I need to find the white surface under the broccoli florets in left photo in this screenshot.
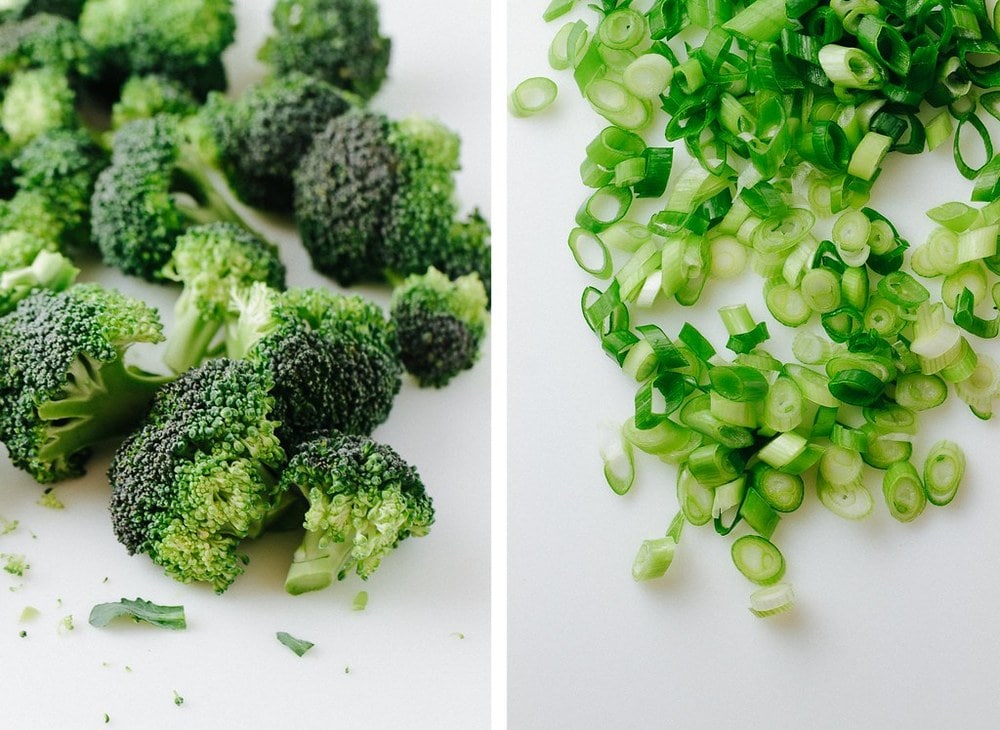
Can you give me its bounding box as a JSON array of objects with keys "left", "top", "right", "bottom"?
[{"left": 0, "top": 0, "right": 490, "bottom": 730}]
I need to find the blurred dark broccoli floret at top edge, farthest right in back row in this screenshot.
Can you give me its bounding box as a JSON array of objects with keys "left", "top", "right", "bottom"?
[{"left": 259, "top": 0, "right": 391, "bottom": 99}]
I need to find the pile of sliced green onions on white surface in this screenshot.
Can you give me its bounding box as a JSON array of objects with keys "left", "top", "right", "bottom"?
[{"left": 511, "top": 0, "right": 1000, "bottom": 616}]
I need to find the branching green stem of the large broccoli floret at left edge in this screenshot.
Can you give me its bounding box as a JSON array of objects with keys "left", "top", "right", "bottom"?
[{"left": 38, "top": 356, "right": 173, "bottom": 461}]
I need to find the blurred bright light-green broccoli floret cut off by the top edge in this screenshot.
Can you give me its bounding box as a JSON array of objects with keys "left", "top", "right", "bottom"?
[{"left": 80, "top": 0, "right": 236, "bottom": 97}]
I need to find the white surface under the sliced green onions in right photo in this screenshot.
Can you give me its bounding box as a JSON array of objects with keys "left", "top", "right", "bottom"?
[{"left": 507, "top": 0, "right": 1000, "bottom": 730}]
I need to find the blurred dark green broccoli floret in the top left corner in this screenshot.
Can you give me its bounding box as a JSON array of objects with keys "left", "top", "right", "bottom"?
[{"left": 0, "top": 13, "right": 94, "bottom": 76}]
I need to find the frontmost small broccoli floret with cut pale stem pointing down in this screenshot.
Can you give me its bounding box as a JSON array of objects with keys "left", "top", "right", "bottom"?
[{"left": 281, "top": 434, "right": 434, "bottom": 594}]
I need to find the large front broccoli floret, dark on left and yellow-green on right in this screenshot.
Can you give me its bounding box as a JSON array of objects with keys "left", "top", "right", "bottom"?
[{"left": 108, "top": 358, "right": 292, "bottom": 592}]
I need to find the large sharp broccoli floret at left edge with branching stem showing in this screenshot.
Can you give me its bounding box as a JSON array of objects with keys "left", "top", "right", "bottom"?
[{"left": 0, "top": 284, "right": 166, "bottom": 483}]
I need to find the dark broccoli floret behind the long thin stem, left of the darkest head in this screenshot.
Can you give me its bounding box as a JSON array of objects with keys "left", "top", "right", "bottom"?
[{"left": 206, "top": 72, "right": 351, "bottom": 211}]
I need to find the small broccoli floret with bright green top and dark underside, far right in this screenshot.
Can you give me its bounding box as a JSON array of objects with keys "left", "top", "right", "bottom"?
[{"left": 389, "top": 267, "right": 489, "bottom": 388}]
